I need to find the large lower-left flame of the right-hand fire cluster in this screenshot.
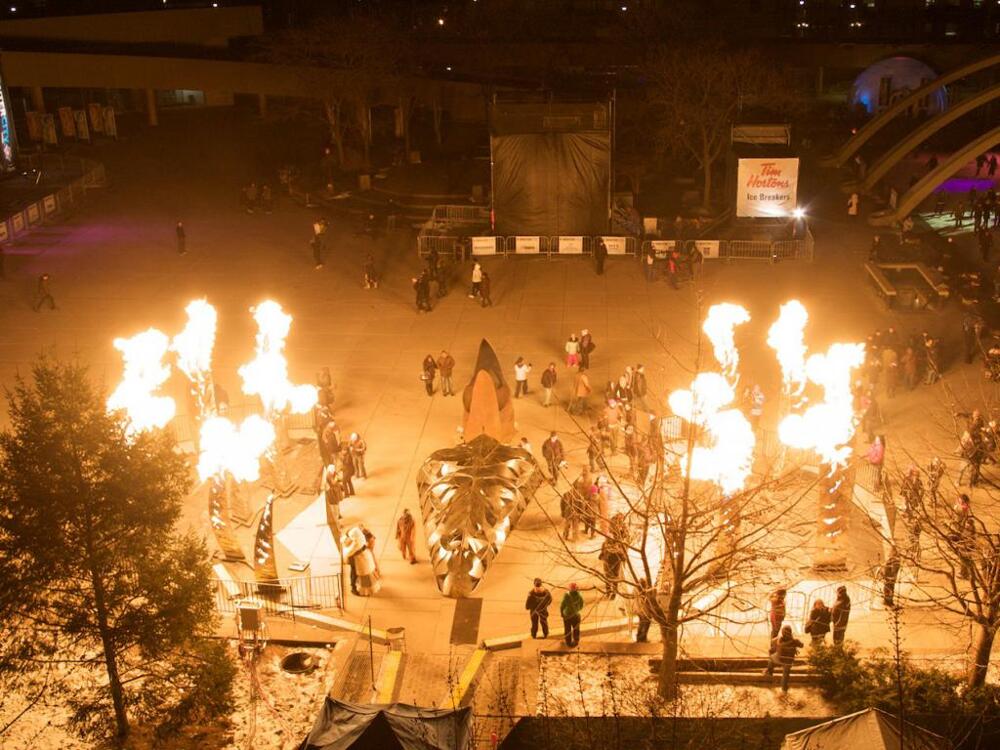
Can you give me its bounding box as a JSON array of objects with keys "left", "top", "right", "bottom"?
[{"left": 668, "top": 372, "right": 757, "bottom": 496}]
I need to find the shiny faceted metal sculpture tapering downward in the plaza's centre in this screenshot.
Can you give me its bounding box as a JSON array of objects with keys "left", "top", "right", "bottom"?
[{"left": 417, "top": 434, "right": 542, "bottom": 598}]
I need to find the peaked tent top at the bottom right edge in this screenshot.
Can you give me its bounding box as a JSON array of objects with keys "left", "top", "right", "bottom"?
[{"left": 781, "top": 708, "right": 951, "bottom": 750}]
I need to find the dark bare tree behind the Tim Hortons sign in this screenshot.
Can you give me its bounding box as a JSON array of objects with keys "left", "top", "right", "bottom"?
[{"left": 644, "top": 43, "right": 794, "bottom": 209}]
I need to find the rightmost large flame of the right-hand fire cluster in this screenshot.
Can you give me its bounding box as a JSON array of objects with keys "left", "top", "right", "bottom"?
[{"left": 778, "top": 344, "right": 865, "bottom": 467}]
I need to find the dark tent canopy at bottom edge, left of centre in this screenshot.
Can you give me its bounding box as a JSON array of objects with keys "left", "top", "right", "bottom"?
[{"left": 299, "top": 697, "right": 472, "bottom": 750}]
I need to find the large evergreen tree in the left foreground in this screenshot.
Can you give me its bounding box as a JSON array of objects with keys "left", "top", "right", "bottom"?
[{"left": 0, "top": 358, "right": 234, "bottom": 742}]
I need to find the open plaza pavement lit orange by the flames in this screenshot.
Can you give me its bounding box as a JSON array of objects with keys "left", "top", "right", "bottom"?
[{"left": 0, "top": 113, "right": 992, "bottom": 703}]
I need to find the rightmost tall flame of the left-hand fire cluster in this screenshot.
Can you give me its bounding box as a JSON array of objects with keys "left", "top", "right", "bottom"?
[{"left": 239, "top": 300, "right": 318, "bottom": 415}]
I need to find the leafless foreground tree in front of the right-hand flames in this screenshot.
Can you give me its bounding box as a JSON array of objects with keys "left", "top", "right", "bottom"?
[{"left": 544, "top": 324, "right": 815, "bottom": 701}]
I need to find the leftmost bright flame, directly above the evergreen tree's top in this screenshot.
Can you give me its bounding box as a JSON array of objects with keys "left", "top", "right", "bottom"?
[{"left": 108, "top": 328, "right": 176, "bottom": 434}]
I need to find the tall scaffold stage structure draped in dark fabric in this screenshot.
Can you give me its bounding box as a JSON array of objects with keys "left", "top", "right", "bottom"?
[{"left": 490, "top": 97, "right": 614, "bottom": 237}]
